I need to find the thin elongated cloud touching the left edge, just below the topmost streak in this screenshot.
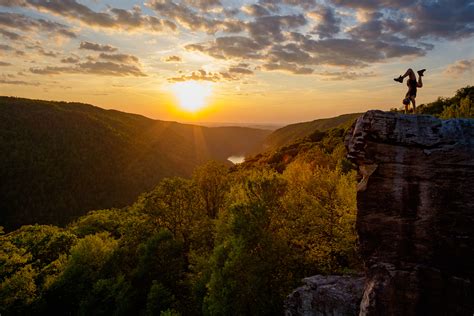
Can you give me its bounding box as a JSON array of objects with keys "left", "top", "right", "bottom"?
[{"left": 0, "top": 11, "right": 77, "bottom": 38}]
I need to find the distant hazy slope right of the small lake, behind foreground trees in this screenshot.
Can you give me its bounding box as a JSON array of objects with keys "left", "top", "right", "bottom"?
[{"left": 263, "top": 113, "right": 361, "bottom": 151}]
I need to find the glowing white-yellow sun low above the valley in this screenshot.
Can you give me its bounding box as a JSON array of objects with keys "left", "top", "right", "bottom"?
[{"left": 171, "top": 81, "right": 212, "bottom": 113}]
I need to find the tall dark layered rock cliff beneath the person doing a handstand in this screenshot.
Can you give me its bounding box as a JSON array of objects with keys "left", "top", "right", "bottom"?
[{"left": 288, "top": 111, "right": 474, "bottom": 316}]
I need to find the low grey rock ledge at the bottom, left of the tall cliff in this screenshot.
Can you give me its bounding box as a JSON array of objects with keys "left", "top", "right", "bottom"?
[{"left": 285, "top": 275, "right": 365, "bottom": 316}]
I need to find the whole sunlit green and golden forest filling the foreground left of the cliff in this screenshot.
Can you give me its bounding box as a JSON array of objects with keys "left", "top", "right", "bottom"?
[{"left": 0, "top": 129, "right": 359, "bottom": 315}]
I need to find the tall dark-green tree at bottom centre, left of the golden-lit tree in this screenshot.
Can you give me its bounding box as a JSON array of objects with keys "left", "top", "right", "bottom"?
[{"left": 205, "top": 171, "right": 292, "bottom": 315}]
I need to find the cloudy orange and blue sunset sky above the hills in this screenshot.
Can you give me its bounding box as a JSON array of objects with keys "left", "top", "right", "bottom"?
[{"left": 0, "top": 0, "right": 474, "bottom": 124}]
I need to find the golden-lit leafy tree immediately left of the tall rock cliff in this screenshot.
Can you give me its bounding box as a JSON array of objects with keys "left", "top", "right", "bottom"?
[{"left": 278, "top": 161, "right": 357, "bottom": 275}]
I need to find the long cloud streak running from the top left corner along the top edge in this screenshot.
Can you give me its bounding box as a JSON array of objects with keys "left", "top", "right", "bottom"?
[{"left": 0, "top": 0, "right": 176, "bottom": 32}]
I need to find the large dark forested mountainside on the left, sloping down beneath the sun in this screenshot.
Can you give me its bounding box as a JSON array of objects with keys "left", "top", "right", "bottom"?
[{"left": 0, "top": 97, "right": 269, "bottom": 229}]
